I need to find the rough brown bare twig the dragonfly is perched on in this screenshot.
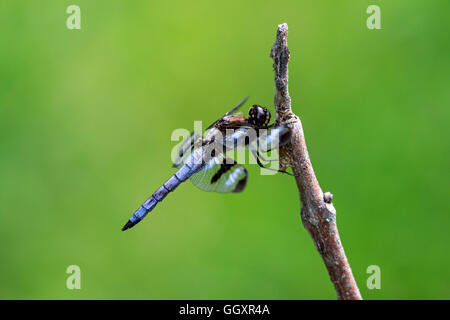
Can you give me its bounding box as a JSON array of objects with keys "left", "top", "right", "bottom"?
[{"left": 270, "top": 23, "right": 362, "bottom": 300}]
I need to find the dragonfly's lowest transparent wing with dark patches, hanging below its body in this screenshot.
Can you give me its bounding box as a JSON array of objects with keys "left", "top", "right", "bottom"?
[{"left": 190, "top": 156, "right": 248, "bottom": 193}]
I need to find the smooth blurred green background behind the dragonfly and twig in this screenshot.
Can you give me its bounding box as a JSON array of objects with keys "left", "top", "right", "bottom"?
[{"left": 0, "top": 0, "right": 450, "bottom": 299}]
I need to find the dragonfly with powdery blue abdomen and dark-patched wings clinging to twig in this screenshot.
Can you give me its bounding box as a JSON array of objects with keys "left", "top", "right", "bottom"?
[{"left": 122, "top": 97, "right": 293, "bottom": 231}]
